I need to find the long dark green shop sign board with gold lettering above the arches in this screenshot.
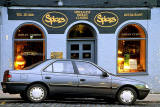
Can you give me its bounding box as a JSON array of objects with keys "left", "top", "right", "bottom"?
[{"left": 8, "top": 8, "right": 151, "bottom": 34}]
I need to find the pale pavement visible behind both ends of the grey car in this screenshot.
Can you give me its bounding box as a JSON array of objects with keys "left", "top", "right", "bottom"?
[{"left": 0, "top": 90, "right": 160, "bottom": 103}]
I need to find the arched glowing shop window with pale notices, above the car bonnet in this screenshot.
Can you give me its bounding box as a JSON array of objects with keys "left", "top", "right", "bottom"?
[{"left": 117, "top": 24, "right": 146, "bottom": 73}]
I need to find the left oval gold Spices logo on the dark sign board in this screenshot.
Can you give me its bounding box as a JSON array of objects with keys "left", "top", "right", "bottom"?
[{"left": 42, "top": 11, "right": 68, "bottom": 28}]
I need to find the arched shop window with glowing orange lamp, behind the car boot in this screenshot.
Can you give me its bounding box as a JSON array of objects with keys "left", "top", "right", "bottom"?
[{"left": 14, "top": 24, "right": 45, "bottom": 70}]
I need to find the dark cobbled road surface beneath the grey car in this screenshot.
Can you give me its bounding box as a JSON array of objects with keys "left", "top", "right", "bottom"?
[{"left": 0, "top": 98, "right": 160, "bottom": 107}]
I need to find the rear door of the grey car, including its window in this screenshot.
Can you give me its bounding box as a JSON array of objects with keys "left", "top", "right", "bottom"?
[{"left": 43, "top": 60, "right": 78, "bottom": 94}]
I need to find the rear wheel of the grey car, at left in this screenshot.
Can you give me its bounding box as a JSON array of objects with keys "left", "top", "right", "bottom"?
[{"left": 27, "top": 84, "right": 47, "bottom": 103}]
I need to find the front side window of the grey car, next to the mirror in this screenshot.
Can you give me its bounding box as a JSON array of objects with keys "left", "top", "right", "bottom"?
[{"left": 75, "top": 62, "right": 102, "bottom": 76}]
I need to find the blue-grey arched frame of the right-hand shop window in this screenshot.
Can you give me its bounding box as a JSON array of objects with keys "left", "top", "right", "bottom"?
[{"left": 116, "top": 23, "right": 148, "bottom": 76}]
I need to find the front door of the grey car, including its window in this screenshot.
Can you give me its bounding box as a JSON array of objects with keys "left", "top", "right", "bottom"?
[{"left": 75, "top": 61, "right": 111, "bottom": 96}]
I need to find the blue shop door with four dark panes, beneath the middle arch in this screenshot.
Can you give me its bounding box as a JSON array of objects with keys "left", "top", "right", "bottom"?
[{"left": 67, "top": 40, "right": 95, "bottom": 62}]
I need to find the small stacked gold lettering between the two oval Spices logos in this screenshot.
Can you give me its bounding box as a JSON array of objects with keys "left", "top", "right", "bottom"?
[{"left": 74, "top": 10, "right": 91, "bottom": 19}]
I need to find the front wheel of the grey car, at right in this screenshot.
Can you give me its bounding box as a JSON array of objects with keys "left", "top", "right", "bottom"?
[{"left": 117, "top": 87, "right": 137, "bottom": 105}]
